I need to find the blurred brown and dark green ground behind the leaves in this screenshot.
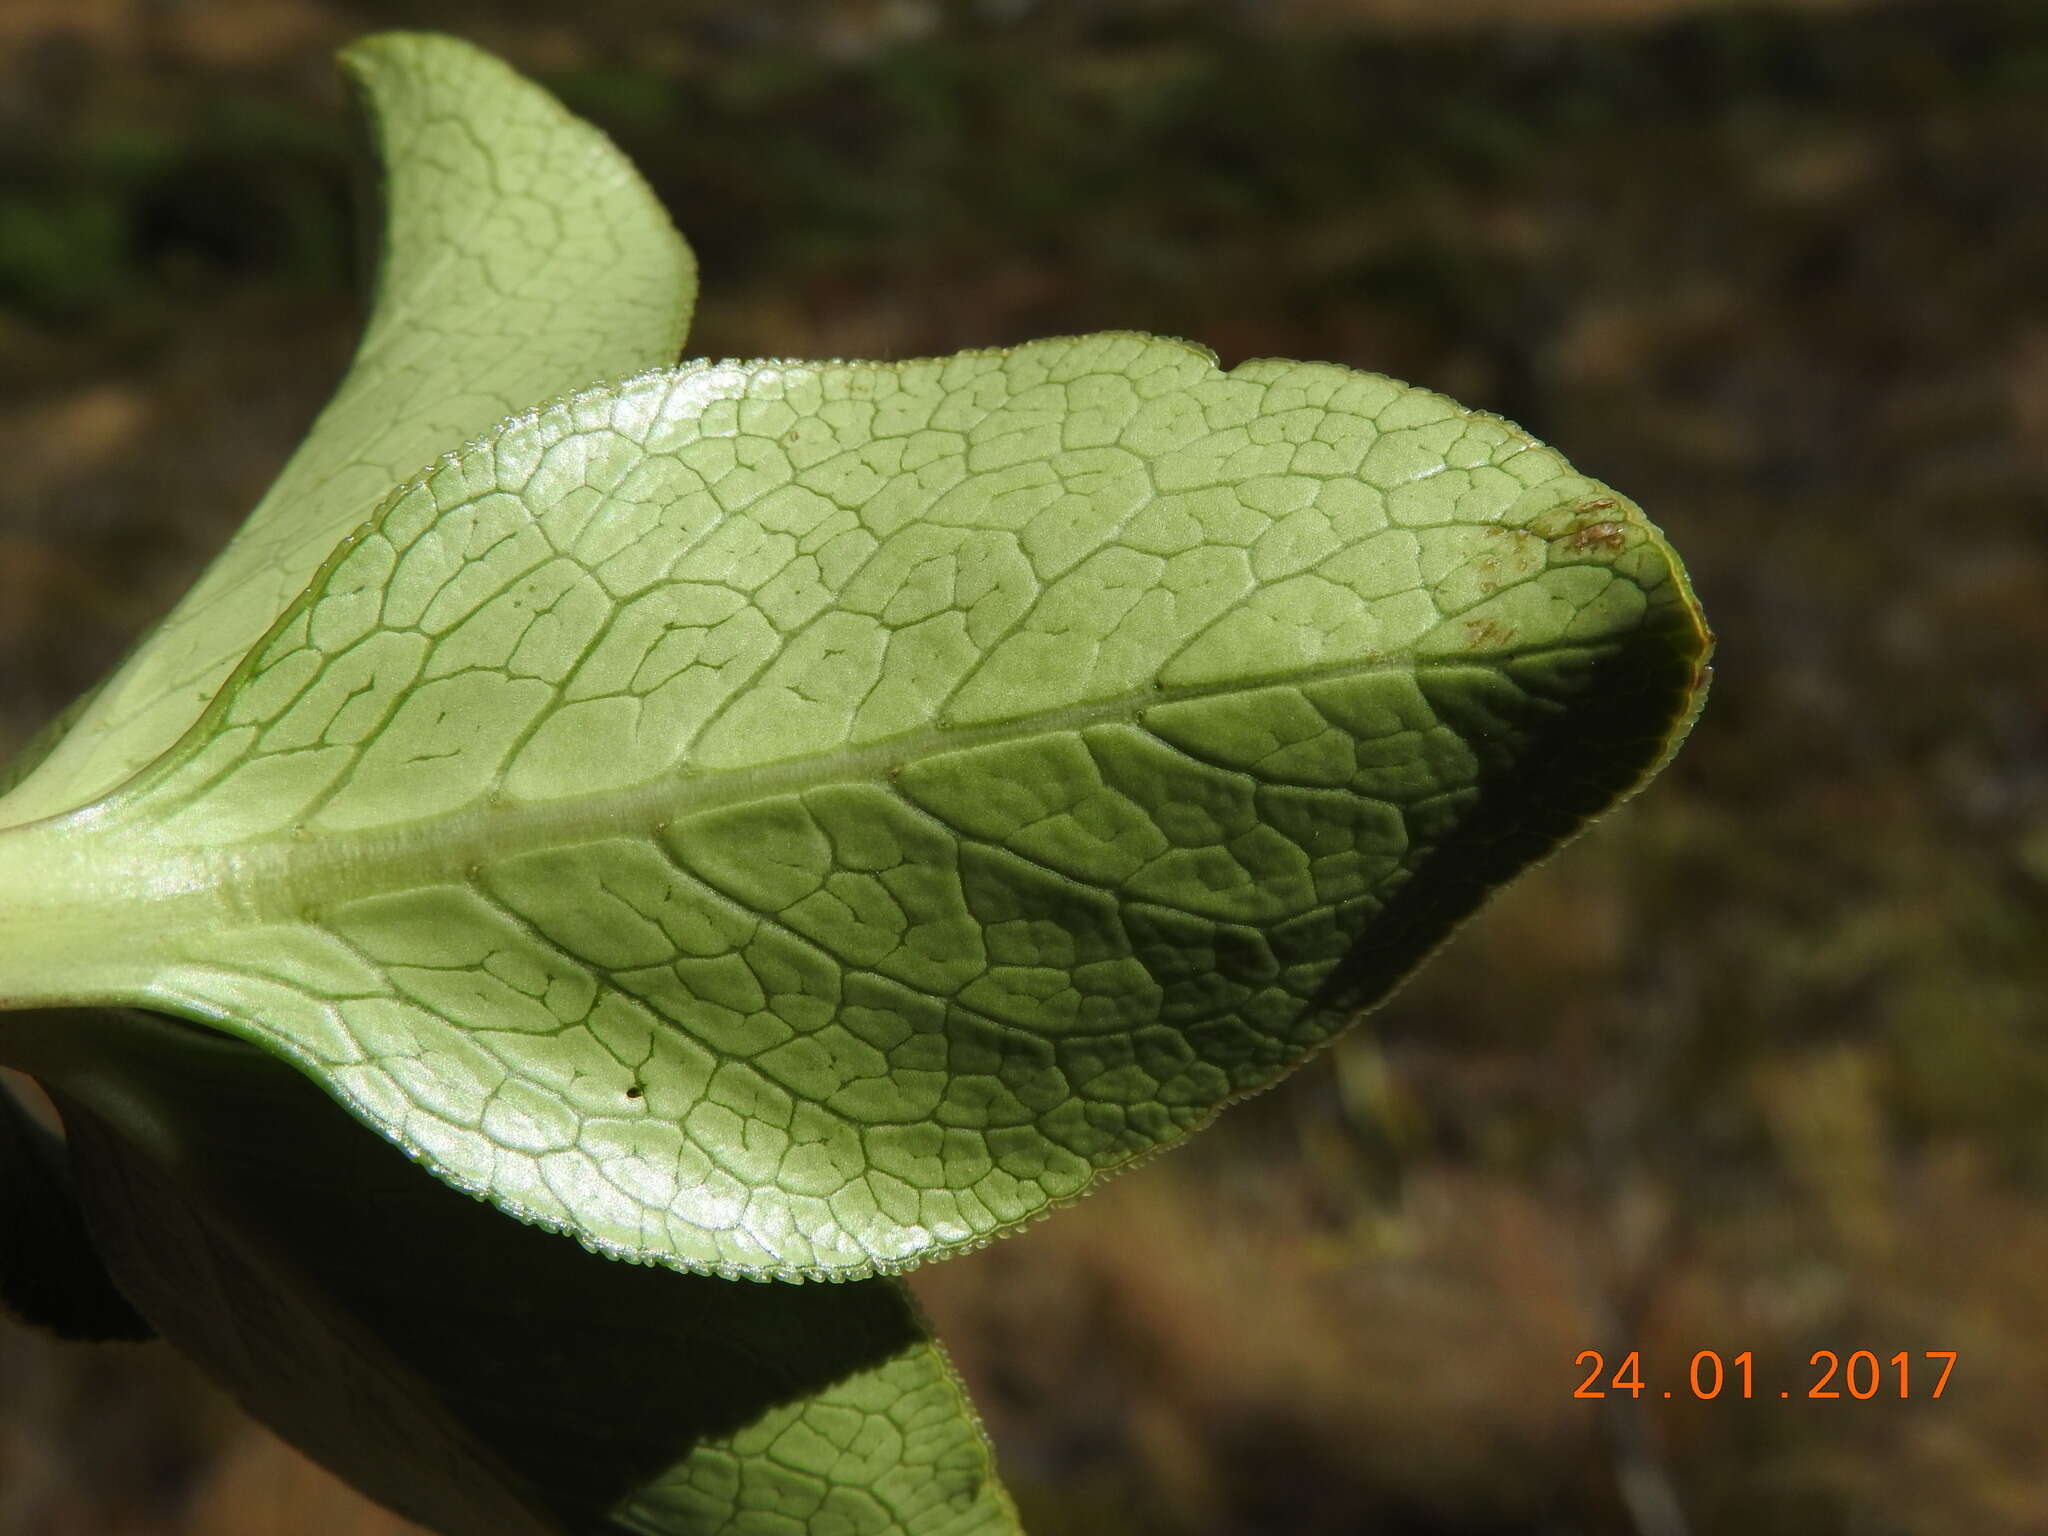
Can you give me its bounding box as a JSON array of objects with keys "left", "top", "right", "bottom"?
[{"left": 0, "top": 0, "right": 2048, "bottom": 1536}]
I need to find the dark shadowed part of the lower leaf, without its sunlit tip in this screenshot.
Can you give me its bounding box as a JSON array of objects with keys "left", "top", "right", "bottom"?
[{"left": 18, "top": 1012, "right": 922, "bottom": 1532}]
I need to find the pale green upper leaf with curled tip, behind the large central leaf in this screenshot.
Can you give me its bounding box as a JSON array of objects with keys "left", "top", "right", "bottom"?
[{"left": 0, "top": 33, "right": 696, "bottom": 821}]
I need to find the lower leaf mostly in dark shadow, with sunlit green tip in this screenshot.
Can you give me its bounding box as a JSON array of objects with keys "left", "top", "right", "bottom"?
[{"left": 23, "top": 1012, "right": 1016, "bottom": 1536}]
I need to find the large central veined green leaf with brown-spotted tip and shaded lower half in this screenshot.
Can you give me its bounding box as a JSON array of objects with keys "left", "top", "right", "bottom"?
[{"left": 0, "top": 334, "right": 1706, "bottom": 1276}]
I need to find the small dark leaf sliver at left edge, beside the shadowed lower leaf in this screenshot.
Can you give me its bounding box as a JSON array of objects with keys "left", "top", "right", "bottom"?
[{"left": 0, "top": 1081, "right": 152, "bottom": 1339}]
